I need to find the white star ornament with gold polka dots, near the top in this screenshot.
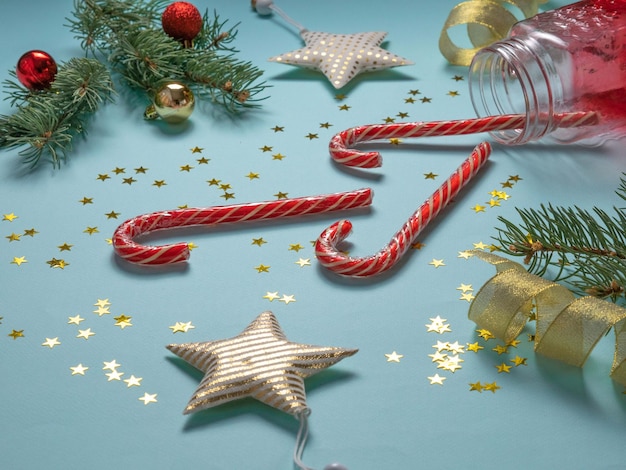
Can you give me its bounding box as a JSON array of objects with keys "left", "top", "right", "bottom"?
[{"left": 269, "top": 30, "right": 413, "bottom": 89}]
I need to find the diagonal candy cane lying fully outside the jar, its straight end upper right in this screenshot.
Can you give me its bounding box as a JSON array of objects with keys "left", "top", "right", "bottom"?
[{"left": 315, "top": 142, "right": 491, "bottom": 277}]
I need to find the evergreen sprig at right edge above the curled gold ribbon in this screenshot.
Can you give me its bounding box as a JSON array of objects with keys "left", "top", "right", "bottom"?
[{"left": 495, "top": 174, "right": 626, "bottom": 303}]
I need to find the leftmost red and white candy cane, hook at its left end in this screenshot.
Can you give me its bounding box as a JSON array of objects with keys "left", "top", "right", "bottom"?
[{"left": 112, "top": 188, "right": 372, "bottom": 265}]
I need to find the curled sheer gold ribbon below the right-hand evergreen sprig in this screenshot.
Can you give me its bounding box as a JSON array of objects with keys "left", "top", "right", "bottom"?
[{"left": 468, "top": 251, "right": 626, "bottom": 386}]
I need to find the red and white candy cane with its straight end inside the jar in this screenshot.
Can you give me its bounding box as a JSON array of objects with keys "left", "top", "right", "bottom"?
[{"left": 328, "top": 112, "right": 597, "bottom": 168}]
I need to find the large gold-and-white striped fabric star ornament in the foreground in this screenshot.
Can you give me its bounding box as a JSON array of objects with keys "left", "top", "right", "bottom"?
[{"left": 167, "top": 311, "right": 357, "bottom": 417}]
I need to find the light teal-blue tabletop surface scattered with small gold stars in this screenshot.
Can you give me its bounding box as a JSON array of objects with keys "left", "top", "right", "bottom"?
[{"left": 0, "top": 0, "right": 626, "bottom": 470}]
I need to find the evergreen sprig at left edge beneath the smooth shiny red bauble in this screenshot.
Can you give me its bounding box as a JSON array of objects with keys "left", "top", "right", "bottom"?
[{"left": 0, "top": 58, "right": 114, "bottom": 168}]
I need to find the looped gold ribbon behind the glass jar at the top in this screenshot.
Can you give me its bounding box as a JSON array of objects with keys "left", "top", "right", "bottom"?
[{"left": 439, "top": 0, "right": 547, "bottom": 65}]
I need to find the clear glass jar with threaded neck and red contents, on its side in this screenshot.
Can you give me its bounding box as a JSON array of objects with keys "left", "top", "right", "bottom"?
[{"left": 469, "top": 0, "right": 626, "bottom": 145}]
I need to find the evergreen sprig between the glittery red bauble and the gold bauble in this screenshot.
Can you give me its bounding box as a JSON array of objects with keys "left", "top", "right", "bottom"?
[{"left": 67, "top": 0, "right": 267, "bottom": 112}]
